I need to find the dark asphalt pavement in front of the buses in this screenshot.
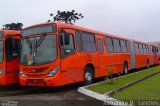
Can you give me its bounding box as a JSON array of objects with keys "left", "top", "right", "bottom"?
[{"left": 0, "top": 83, "right": 104, "bottom": 106}]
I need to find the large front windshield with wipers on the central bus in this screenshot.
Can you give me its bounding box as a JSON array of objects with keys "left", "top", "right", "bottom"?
[{"left": 20, "top": 34, "right": 57, "bottom": 65}]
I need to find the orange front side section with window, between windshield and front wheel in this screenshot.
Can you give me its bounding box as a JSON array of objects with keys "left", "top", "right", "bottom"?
[{"left": 59, "top": 30, "right": 83, "bottom": 83}]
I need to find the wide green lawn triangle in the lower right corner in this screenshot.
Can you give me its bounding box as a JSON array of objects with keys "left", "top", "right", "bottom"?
[{"left": 112, "top": 74, "right": 160, "bottom": 100}]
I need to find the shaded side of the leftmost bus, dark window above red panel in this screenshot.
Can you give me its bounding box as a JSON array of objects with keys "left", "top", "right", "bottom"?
[{"left": 5, "top": 38, "right": 19, "bottom": 83}]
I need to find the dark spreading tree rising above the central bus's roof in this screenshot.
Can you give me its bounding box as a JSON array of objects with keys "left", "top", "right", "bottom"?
[{"left": 48, "top": 10, "right": 84, "bottom": 24}]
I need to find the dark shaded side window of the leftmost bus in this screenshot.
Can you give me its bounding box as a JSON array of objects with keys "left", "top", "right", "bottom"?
[{"left": 6, "top": 38, "right": 19, "bottom": 61}]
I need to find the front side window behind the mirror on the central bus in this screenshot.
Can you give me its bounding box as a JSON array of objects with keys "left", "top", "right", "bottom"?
[{"left": 60, "top": 33, "right": 75, "bottom": 58}]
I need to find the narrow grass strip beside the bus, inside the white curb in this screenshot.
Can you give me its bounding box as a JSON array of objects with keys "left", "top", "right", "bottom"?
[{"left": 87, "top": 66, "right": 160, "bottom": 94}]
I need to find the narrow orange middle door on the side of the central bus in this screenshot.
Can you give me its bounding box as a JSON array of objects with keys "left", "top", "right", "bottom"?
[{"left": 96, "top": 35, "right": 106, "bottom": 76}]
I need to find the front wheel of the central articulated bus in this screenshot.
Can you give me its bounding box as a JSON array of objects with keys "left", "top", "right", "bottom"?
[{"left": 84, "top": 67, "right": 94, "bottom": 85}]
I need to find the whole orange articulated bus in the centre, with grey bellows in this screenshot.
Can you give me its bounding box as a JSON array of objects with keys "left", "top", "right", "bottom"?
[{"left": 19, "top": 22, "right": 153, "bottom": 86}]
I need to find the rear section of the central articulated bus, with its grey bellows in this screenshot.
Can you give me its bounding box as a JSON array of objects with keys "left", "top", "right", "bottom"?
[{"left": 130, "top": 40, "right": 154, "bottom": 69}]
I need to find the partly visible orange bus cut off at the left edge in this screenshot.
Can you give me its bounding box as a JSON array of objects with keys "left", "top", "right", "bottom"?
[{"left": 0, "top": 30, "right": 21, "bottom": 85}]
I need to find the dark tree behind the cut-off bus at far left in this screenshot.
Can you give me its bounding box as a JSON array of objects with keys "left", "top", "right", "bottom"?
[{"left": 2, "top": 23, "right": 23, "bottom": 30}]
